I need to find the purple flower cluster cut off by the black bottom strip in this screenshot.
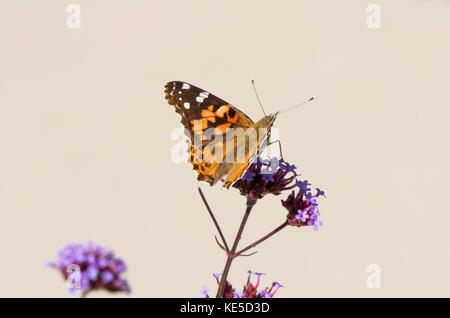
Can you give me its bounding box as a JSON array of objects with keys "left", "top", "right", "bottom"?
[{"left": 201, "top": 271, "right": 283, "bottom": 298}]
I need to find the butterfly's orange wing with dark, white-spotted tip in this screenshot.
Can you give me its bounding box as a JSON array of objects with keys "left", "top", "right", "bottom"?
[{"left": 165, "top": 81, "right": 254, "bottom": 188}]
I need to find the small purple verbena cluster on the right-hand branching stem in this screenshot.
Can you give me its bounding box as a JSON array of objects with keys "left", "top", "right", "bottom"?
[{"left": 281, "top": 180, "right": 325, "bottom": 231}]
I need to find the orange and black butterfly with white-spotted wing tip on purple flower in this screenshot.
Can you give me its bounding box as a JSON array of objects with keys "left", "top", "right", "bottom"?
[{"left": 165, "top": 81, "right": 278, "bottom": 189}]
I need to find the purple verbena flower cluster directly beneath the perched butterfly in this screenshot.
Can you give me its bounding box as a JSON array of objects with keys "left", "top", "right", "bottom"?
[{"left": 233, "top": 157, "right": 297, "bottom": 199}]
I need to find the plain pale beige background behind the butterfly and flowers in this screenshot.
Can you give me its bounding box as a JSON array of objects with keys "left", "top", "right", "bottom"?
[{"left": 0, "top": 0, "right": 450, "bottom": 297}]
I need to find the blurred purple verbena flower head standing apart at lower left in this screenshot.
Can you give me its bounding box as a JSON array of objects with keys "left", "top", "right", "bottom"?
[{"left": 48, "top": 242, "right": 130, "bottom": 294}]
